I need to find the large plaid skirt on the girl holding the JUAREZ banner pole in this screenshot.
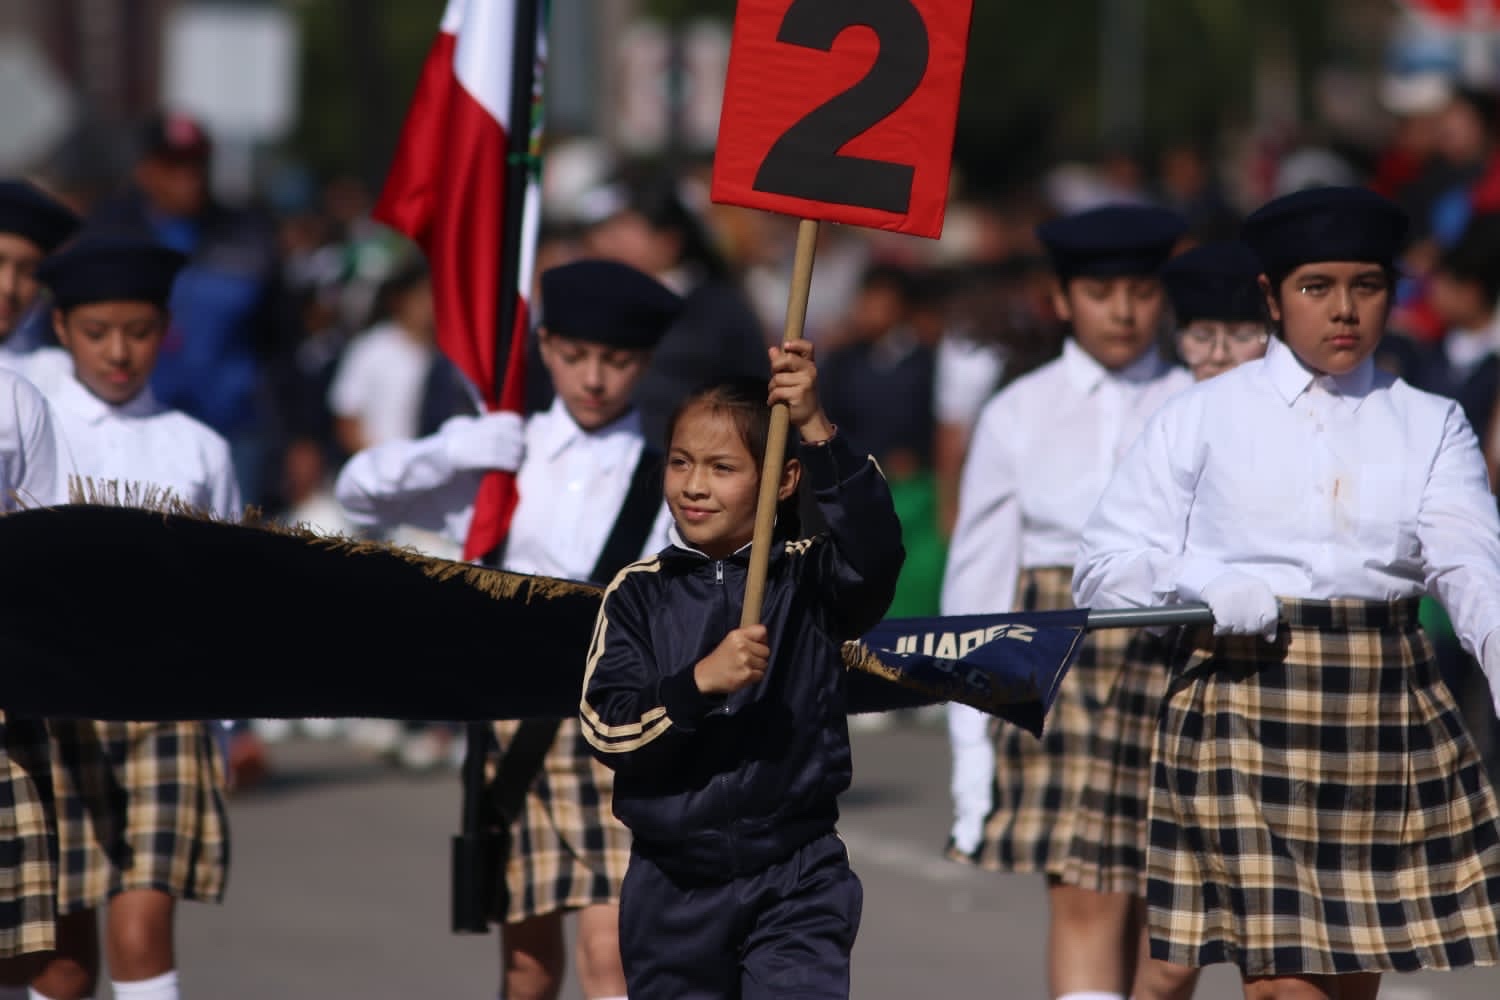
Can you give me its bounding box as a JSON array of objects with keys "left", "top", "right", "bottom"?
[{"left": 1148, "top": 598, "right": 1500, "bottom": 976}]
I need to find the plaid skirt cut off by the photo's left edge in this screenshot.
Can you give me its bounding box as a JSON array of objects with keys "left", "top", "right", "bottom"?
[{"left": 0, "top": 715, "right": 57, "bottom": 958}]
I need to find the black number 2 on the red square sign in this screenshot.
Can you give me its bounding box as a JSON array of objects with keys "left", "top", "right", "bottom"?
[{"left": 755, "top": 0, "right": 930, "bottom": 214}]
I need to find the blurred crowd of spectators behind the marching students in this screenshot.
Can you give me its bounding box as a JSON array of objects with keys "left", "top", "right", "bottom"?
[{"left": 0, "top": 0, "right": 1500, "bottom": 766}]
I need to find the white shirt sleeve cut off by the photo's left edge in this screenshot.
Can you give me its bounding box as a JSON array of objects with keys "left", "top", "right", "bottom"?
[{"left": 0, "top": 369, "right": 72, "bottom": 511}]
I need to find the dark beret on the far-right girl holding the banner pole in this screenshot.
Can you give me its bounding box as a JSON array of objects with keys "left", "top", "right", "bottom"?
[{"left": 1241, "top": 187, "right": 1410, "bottom": 280}]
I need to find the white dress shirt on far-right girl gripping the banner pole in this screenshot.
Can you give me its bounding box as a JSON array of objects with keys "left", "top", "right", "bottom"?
[{"left": 1074, "top": 339, "right": 1500, "bottom": 671}]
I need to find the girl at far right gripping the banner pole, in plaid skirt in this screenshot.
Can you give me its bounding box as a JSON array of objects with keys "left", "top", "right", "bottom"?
[{"left": 1074, "top": 187, "right": 1500, "bottom": 1000}]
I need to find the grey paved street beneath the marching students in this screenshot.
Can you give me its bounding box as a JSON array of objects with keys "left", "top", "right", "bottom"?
[{"left": 138, "top": 727, "right": 1500, "bottom": 1000}]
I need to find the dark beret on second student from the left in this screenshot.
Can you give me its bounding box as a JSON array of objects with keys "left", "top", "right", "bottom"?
[{"left": 36, "top": 235, "right": 188, "bottom": 309}]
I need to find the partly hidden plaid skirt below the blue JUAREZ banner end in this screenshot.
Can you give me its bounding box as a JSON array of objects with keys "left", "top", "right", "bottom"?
[{"left": 969, "top": 567, "right": 1131, "bottom": 876}]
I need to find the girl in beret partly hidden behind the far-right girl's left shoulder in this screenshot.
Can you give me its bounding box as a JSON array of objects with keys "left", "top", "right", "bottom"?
[{"left": 942, "top": 205, "right": 1193, "bottom": 1000}]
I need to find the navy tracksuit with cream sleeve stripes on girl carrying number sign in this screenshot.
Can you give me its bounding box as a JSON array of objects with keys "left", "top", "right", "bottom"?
[{"left": 581, "top": 435, "right": 905, "bottom": 1000}]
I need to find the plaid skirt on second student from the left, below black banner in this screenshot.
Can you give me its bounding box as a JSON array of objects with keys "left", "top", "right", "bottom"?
[{"left": 48, "top": 720, "right": 230, "bottom": 913}]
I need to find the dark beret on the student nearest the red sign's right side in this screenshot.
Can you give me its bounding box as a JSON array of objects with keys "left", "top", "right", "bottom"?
[{"left": 1037, "top": 204, "right": 1188, "bottom": 280}]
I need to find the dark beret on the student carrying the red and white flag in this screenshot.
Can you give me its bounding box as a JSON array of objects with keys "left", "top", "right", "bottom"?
[{"left": 542, "top": 259, "right": 683, "bottom": 351}]
